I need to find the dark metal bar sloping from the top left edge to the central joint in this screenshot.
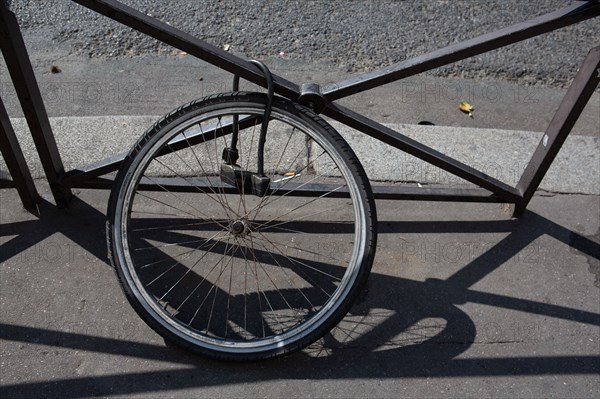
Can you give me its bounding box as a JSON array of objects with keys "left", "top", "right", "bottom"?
[{"left": 73, "top": 0, "right": 299, "bottom": 100}]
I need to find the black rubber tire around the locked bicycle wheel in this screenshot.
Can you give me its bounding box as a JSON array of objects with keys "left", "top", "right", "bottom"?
[{"left": 106, "top": 92, "right": 376, "bottom": 361}]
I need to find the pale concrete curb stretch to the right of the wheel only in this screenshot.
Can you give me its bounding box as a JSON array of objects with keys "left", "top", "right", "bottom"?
[{"left": 333, "top": 123, "right": 600, "bottom": 195}]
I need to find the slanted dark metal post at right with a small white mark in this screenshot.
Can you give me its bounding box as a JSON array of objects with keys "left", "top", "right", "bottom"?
[{"left": 514, "top": 46, "right": 600, "bottom": 217}]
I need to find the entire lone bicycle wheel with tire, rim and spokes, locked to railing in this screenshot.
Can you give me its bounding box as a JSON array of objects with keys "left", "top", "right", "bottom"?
[{"left": 107, "top": 93, "right": 376, "bottom": 361}]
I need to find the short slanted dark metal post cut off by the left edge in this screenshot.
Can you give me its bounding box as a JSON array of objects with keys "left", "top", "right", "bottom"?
[{"left": 0, "top": 98, "right": 39, "bottom": 214}]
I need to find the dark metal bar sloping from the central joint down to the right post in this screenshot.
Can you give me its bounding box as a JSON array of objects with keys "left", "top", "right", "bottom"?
[{"left": 323, "top": 103, "right": 520, "bottom": 202}]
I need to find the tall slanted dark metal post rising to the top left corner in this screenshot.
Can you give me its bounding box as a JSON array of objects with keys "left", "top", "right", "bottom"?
[{"left": 0, "top": 2, "right": 71, "bottom": 207}]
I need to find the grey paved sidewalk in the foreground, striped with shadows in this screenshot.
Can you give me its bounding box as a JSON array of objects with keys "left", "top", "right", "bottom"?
[{"left": 0, "top": 182, "right": 600, "bottom": 398}]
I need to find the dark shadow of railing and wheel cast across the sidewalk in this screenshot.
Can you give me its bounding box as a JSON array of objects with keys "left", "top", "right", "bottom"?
[{"left": 0, "top": 196, "right": 600, "bottom": 398}]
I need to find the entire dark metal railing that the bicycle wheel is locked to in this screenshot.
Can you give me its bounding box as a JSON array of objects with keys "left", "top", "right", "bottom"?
[{"left": 0, "top": 0, "right": 600, "bottom": 216}]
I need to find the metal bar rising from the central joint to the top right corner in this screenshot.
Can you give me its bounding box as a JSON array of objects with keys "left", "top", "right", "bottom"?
[{"left": 321, "top": 1, "right": 600, "bottom": 101}]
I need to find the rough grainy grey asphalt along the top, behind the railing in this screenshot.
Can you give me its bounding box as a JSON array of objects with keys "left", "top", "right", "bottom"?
[{"left": 7, "top": 0, "right": 600, "bottom": 86}]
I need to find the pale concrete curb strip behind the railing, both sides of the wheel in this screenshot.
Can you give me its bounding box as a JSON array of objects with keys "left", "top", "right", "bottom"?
[{"left": 0, "top": 116, "right": 600, "bottom": 195}]
